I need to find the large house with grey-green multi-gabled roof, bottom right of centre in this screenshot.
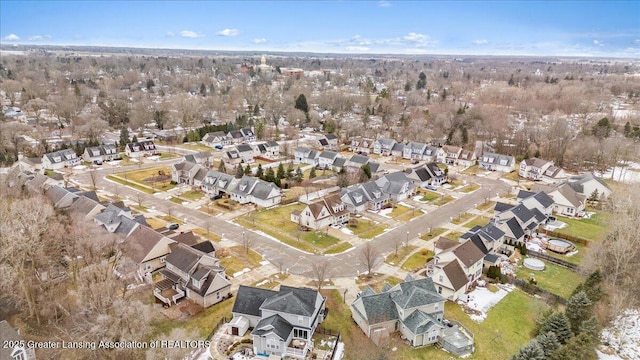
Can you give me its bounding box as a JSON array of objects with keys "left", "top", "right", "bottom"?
[{"left": 350, "top": 277, "right": 460, "bottom": 347}]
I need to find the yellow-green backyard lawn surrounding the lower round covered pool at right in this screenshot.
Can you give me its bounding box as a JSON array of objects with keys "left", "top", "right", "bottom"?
[{"left": 516, "top": 262, "right": 584, "bottom": 298}]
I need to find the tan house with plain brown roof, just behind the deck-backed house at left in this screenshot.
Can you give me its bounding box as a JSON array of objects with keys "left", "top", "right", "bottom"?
[{"left": 120, "top": 225, "right": 176, "bottom": 278}]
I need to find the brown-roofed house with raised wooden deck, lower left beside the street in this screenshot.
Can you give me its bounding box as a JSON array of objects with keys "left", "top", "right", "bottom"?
[{"left": 153, "top": 241, "right": 231, "bottom": 308}]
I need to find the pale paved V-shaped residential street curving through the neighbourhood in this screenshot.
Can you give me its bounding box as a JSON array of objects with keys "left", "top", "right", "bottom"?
[{"left": 73, "top": 163, "right": 510, "bottom": 277}]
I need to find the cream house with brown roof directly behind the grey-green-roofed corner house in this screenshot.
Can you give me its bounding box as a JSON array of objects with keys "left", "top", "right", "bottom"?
[{"left": 431, "top": 240, "right": 485, "bottom": 301}]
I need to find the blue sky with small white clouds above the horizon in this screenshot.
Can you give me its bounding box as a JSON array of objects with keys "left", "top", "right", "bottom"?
[{"left": 0, "top": 0, "right": 640, "bottom": 58}]
